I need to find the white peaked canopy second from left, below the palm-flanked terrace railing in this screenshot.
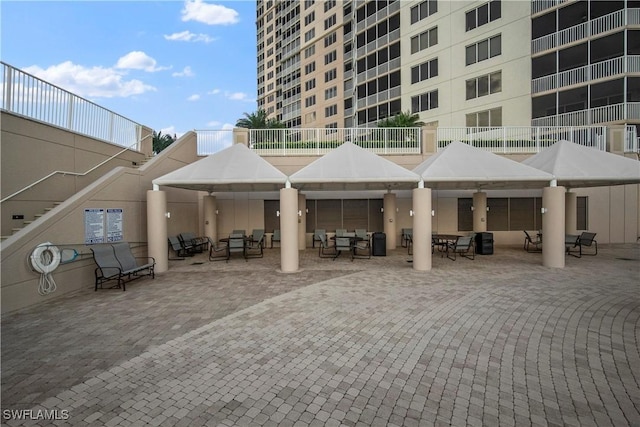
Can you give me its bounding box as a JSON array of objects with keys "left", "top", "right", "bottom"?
[{"left": 289, "top": 142, "right": 420, "bottom": 191}]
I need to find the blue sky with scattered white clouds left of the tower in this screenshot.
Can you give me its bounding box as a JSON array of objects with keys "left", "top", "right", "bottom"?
[{"left": 0, "top": 0, "right": 257, "bottom": 136}]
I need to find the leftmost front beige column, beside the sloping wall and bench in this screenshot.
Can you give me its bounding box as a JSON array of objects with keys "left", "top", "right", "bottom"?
[{"left": 147, "top": 190, "right": 169, "bottom": 273}]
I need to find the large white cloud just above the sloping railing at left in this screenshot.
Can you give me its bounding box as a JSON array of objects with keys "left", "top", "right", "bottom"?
[{"left": 24, "top": 61, "right": 156, "bottom": 98}]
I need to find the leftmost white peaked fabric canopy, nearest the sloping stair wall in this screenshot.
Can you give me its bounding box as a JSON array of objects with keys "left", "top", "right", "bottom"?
[{"left": 153, "top": 144, "right": 287, "bottom": 192}]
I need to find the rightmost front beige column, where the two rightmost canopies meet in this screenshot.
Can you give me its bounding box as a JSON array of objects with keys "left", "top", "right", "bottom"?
[{"left": 542, "top": 187, "right": 565, "bottom": 268}]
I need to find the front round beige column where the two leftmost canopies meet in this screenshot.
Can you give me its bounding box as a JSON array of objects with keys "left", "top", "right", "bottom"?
[{"left": 280, "top": 188, "right": 299, "bottom": 273}]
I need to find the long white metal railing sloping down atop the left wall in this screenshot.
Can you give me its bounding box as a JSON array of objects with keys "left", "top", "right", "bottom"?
[{"left": 0, "top": 62, "right": 142, "bottom": 151}]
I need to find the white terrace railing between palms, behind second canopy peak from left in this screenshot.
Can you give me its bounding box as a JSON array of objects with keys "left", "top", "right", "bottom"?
[{"left": 249, "top": 128, "right": 422, "bottom": 156}]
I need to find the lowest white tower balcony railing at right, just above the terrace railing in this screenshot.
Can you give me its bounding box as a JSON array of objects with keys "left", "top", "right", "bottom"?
[{"left": 531, "top": 102, "right": 640, "bottom": 126}]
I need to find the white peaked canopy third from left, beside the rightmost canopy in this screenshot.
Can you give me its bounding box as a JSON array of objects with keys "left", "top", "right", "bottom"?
[{"left": 413, "top": 141, "right": 553, "bottom": 190}]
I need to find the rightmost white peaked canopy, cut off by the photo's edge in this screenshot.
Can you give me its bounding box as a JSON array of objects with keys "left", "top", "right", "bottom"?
[{"left": 522, "top": 140, "right": 640, "bottom": 188}]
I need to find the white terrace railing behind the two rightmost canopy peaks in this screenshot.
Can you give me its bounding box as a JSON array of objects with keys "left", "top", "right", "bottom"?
[{"left": 436, "top": 126, "right": 607, "bottom": 154}]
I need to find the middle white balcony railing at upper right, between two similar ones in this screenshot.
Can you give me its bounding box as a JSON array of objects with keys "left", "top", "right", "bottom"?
[{"left": 531, "top": 55, "right": 640, "bottom": 93}]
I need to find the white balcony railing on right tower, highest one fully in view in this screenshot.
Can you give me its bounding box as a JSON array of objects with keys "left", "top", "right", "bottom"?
[{"left": 531, "top": 9, "right": 640, "bottom": 54}]
